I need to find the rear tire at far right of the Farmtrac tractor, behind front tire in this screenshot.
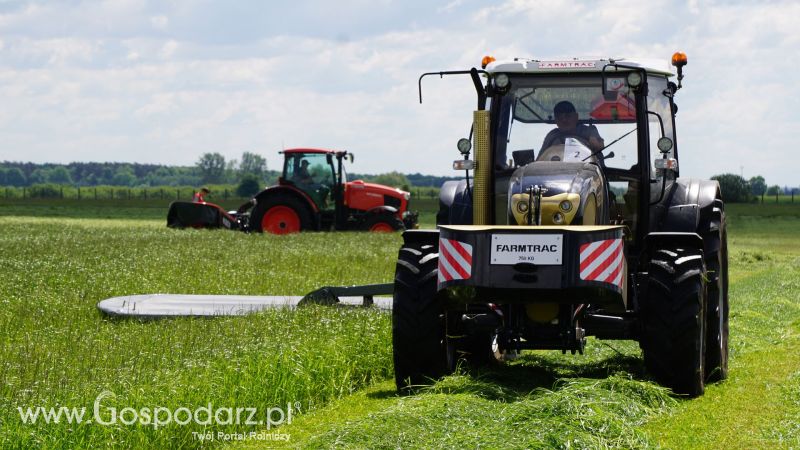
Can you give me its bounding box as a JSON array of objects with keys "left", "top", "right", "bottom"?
[{"left": 702, "top": 199, "right": 729, "bottom": 382}]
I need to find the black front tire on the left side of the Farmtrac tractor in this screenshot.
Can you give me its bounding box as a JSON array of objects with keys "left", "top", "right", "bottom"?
[{"left": 392, "top": 242, "right": 448, "bottom": 393}]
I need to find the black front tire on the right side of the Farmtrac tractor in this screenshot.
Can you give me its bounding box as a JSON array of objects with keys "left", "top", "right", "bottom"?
[{"left": 640, "top": 249, "right": 707, "bottom": 397}]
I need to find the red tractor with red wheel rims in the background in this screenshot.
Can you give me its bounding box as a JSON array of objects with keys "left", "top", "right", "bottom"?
[{"left": 238, "top": 148, "right": 417, "bottom": 234}]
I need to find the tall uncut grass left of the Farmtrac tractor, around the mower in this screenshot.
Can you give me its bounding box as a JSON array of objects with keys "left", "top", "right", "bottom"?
[{"left": 0, "top": 217, "right": 399, "bottom": 448}]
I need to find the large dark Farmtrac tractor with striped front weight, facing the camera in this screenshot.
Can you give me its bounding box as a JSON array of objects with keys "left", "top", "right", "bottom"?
[{"left": 392, "top": 52, "right": 729, "bottom": 397}]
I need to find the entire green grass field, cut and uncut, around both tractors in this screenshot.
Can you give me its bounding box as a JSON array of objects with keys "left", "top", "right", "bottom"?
[{"left": 0, "top": 201, "right": 800, "bottom": 448}]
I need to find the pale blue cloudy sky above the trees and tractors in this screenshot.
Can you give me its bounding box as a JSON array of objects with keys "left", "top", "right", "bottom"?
[{"left": 0, "top": 0, "right": 800, "bottom": 186}]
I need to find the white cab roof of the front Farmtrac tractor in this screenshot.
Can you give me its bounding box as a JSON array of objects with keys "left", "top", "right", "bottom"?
[{"left": 484, "top": 58, "right": 674, "bottom": 77}]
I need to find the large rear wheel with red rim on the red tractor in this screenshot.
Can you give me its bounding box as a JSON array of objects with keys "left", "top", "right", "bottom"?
[{"left": 250, "top": 195, "right": 312, "bottom": 234}]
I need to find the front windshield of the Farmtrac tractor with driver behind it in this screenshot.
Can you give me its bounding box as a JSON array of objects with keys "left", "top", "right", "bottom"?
[{"left": 495, "top": 74, "right": 637, "bottom": 169}]
